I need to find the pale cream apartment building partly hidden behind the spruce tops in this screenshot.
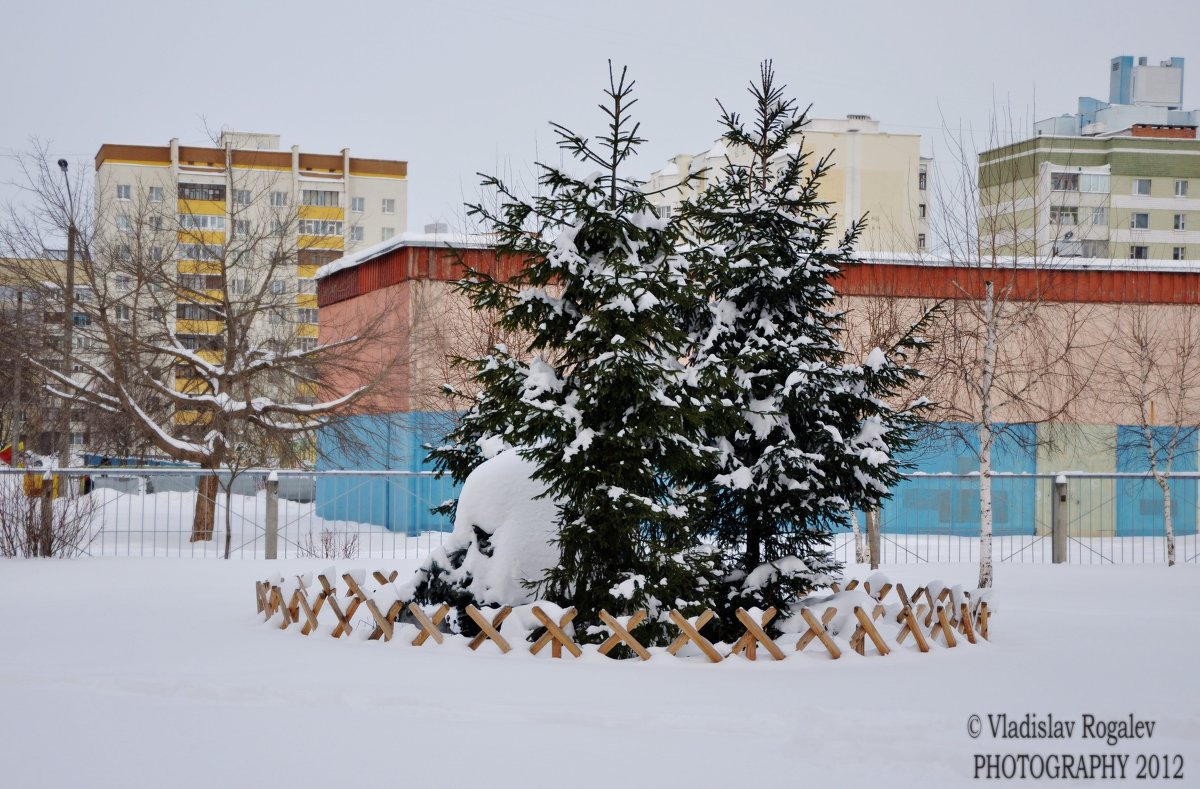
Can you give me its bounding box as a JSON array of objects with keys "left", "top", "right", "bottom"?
[{"left": 643, "top": 115, "right": 932, "bottom": 253}]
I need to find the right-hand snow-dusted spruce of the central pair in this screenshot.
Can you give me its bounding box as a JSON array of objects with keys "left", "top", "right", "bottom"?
[{"left": 684, "top": 61, "right": 922, "bottom": 637}]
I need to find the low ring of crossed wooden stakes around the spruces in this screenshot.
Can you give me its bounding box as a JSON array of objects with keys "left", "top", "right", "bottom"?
[{"left": 254, "top": 567, "right": 994, "bottom": 663}]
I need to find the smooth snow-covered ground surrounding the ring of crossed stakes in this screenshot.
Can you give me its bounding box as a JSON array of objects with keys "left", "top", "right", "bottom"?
[{"left": 0, "top": 559, "right": 1200, "bottom": 789}]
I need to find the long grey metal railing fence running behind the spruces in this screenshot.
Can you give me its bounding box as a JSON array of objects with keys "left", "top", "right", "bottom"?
[{"left": 0, "top": 468, "right": 1200, "bottom": 564}]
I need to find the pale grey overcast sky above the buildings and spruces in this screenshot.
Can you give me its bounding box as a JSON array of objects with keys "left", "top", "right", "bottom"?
[{"left": 0, "top": 0, "right": 1200, "bottom": 230}]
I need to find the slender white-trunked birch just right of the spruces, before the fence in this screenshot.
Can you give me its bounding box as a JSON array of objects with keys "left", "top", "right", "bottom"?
[{"left": 932, "top": 115, "right": 1094, "bottom": 588}]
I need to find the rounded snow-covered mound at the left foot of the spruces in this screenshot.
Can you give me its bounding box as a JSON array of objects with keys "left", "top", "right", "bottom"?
[{"left": 401, "top": 450, "right": 558, "bottom": 606}]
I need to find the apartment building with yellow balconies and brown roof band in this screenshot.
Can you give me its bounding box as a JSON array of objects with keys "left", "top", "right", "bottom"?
[{"left": 91, "top": 132, "right": 408, "bottom": 424}]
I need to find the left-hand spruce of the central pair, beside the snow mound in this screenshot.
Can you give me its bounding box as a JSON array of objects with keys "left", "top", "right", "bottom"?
[{"left": 431, "top": 62, "right": 713, "bottom": 643}]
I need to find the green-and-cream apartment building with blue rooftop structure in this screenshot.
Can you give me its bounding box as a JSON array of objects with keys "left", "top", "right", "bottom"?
[{"left": 979, "top": 55, "right": 1200, "bottom": 260}]
